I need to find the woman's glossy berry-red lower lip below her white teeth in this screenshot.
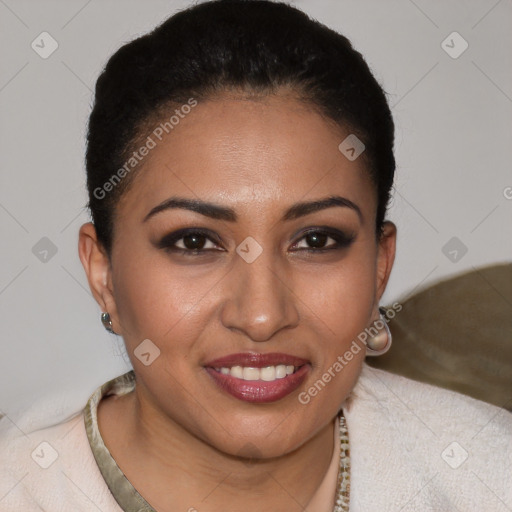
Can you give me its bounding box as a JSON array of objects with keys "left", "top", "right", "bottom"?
[{"left": 206, "top": 364, "right": 309, "bottom": 403}]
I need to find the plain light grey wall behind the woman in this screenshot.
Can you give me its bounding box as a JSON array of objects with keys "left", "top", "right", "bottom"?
[{"left": 0, "top": 0, "right": 512, "bottom": 420}]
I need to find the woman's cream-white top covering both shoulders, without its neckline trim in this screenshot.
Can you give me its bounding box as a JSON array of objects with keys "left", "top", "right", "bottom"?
[{"left": 0, "top": 364, "right": 512, "bottom": 512}]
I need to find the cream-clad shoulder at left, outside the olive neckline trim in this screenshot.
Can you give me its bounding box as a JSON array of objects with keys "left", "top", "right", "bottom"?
[{"left": 0, "top": 400, "right": 121, "bottom": 512}]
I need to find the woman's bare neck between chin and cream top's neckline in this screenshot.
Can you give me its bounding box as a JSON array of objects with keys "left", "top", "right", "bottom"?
[{"left": 112, "top": 387, "right": 334, "bottom": 512}]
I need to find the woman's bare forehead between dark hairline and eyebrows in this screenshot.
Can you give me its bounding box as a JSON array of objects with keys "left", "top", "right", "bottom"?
[{"left": 118, "top": 95, "right": 376, "bottom": 224}]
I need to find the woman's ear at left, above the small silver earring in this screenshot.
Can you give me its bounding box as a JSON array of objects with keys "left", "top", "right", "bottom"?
[{"left": 78, "top": 222, "right": 122, "bottom": 334}]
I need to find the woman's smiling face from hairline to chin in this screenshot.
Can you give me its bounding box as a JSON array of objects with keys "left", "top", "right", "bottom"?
[{"left": 83, "top": 94, "right": 395, "bottom": 457}]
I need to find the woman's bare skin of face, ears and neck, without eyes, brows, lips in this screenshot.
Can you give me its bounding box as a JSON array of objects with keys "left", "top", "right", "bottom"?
[{"left": 79, "top": 92, "right": 396, "bottom": 512}]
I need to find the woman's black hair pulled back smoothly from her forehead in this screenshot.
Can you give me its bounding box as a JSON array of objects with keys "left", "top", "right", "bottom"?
[{"left": 86, "top": 0, "right": 395, "bottom": 255}]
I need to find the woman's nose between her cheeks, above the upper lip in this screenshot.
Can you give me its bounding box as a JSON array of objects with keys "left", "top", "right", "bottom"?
[{"left": 221, "top": 251, "right": 299, "bottom": 342}]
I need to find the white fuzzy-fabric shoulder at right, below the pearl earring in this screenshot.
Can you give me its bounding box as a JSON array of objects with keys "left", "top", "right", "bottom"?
[{"left": 344, "top": 365, "right": 512, "bottom": 511}]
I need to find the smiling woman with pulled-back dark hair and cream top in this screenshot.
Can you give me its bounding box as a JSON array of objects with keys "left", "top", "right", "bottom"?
[{"left": 0, "top": 0, "right": 512, "bottom": 512}]
